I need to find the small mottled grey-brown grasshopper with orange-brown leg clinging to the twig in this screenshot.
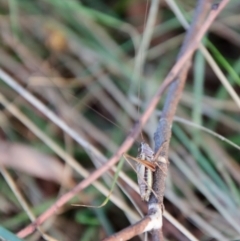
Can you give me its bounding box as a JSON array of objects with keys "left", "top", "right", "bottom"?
[{"left": 125, "top": 142, "right": 156, "bottom": 202}]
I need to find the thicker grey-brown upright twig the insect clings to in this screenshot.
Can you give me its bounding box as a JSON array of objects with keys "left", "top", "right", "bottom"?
[{"left": 149, "top": 0, "right": 230, "bottom": 241}]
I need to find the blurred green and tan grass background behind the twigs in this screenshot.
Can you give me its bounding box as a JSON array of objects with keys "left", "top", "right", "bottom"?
[{"left": 0, "top": 0, "right": 240, "bottom": 241}]
